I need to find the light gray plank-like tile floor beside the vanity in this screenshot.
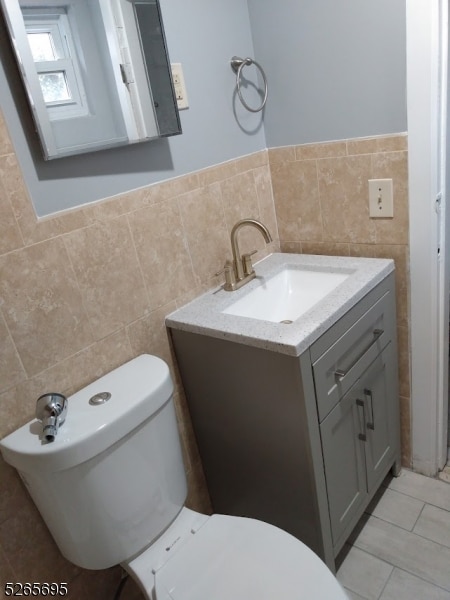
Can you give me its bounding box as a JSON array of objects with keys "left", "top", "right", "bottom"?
[{"left": 337, "top": 470, "right": 450, "bottom": 600}]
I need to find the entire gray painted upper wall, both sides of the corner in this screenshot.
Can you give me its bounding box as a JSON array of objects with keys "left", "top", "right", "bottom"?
[{"left": 0, "top": 0, "right": 407, "bottom": 216}]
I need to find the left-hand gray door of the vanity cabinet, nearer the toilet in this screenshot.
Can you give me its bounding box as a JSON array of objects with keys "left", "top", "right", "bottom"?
[{"left": 320, "top": 386, "right": 367, "bottom": 546}]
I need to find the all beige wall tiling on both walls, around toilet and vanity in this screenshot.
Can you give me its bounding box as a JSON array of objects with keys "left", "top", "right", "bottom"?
[{"left": 0, "top": 108, "right": 409, "bottom": 600}]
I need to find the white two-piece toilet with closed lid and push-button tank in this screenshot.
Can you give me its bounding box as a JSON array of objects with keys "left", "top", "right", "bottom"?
[{"left": 0, "top": 355, "right": 348, "bottom": 600}]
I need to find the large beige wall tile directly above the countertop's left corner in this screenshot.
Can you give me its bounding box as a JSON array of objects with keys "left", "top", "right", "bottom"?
[{"left": 128, "top": 199, "right": 197, "bottom": 310}]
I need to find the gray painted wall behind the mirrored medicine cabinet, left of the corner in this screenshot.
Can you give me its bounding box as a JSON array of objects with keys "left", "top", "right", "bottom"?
[{"left": 0, "top": 0, "right": 266, "bottom": 216}]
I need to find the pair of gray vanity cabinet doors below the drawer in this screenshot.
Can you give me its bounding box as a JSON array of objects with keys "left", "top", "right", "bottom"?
[{"left": 320, "top": 344, "right": 398, "bottom": 548}]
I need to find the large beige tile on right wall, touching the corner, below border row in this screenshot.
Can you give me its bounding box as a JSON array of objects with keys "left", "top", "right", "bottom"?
[{"left": 271, "top": 160, "right": 323, "bottom": 242}]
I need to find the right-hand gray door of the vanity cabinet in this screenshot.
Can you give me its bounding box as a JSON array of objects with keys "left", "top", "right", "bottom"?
[{"left": 358, "top": 344, "right": 396, "bottom": 493}]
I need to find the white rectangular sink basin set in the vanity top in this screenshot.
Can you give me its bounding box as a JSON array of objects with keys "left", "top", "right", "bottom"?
[{"left": 222, "top": 266, "right": 352, "bottom": 323}]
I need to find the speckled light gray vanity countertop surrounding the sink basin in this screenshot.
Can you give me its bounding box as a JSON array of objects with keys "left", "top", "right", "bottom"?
[{"left": 166, "top": 253, "right": 394, "bottom": 356}]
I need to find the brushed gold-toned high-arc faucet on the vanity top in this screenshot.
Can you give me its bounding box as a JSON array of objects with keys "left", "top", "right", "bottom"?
[{"left": 218, "top": 219, "right": 272, "bottom": 292}]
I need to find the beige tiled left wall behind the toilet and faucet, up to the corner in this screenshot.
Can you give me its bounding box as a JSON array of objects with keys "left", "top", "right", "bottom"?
[{"left": 0, "top": 110, "right": 279, "bottom": 600}]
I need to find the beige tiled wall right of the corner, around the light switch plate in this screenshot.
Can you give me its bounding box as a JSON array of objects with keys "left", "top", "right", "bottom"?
[{"left": 269, "top": 135, "right": 411, "bottom": 466}]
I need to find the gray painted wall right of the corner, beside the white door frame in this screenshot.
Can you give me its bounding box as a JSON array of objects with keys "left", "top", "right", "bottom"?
[{"left": 248, "top": 0, "right": 407, "bottom": 147}]
